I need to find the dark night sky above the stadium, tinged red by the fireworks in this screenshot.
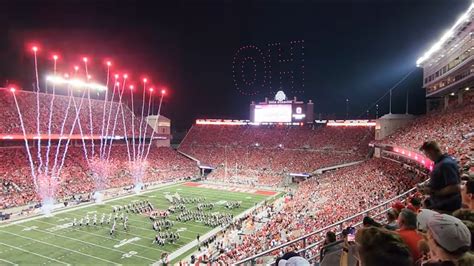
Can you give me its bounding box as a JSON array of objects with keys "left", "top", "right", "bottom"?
[{"left": 0, "top": 0, "right": 471, "bottom": 129}]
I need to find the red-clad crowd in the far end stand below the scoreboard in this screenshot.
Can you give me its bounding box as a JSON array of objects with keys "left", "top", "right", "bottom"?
[{"left": 180, "top": 125, "right": 374, "bottom": 185}]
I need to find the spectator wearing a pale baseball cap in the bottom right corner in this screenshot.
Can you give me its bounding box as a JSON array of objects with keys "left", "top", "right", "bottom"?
[{"left": 417, "top": 209, "right": 474, "bottom": 266}]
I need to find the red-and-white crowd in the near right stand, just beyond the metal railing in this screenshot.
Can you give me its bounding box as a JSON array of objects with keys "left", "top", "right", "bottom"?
[{"left": 213, "top": 159, "right": 422, "bottom": 264}]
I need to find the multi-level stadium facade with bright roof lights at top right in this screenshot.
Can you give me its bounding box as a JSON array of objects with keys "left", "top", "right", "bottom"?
[{"left": 416, "top": 3, "right": 474, "bottom": 112}]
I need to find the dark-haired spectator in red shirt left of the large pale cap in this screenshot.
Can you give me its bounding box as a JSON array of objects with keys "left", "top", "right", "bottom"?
[{"left": 397, "top": 209, "right": 423, "bottom": 262}]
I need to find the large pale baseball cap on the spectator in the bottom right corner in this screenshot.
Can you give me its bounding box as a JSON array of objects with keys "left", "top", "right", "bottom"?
[{"left": 428, "top": 214, "right": 471, "bottom": 252}]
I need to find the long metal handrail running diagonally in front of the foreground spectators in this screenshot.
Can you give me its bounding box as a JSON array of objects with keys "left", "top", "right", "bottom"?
[{"left": 234, "top": 184, "right": 416, "bottom": 265}]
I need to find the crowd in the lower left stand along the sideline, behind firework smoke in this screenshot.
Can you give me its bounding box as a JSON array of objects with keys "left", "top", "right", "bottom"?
[{"left": 0, "top": 145, "right": 197, "bottom": 209}]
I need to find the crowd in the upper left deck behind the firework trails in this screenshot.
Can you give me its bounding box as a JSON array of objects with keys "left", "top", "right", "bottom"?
[{"left": 0, "top": 89, "right": 151, "bottom": 136}]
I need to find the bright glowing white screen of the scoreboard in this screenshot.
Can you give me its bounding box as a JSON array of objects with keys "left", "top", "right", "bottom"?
[{"left": 255, "top": 104, "right": 292, "bottom": 123}]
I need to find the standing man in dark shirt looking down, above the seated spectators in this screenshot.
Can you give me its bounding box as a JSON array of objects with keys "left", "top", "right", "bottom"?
[{"left": 418, "top": 141, "right": 462, "bottom": 213}]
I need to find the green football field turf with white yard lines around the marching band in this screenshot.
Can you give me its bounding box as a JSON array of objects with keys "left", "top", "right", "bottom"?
[{"left": 0, "top": 185, "right": 268, "bottom": 265}]
